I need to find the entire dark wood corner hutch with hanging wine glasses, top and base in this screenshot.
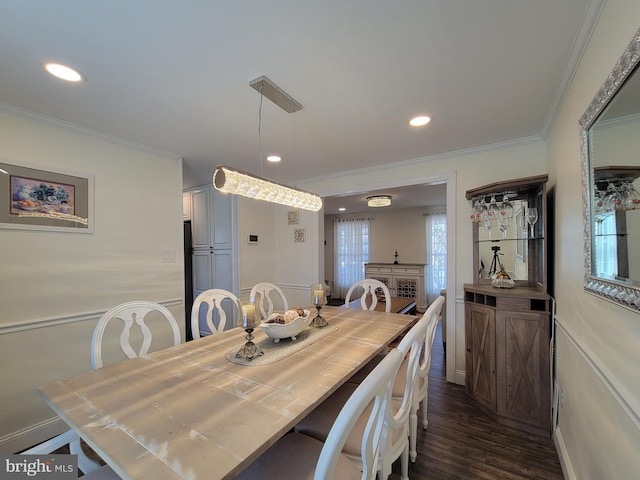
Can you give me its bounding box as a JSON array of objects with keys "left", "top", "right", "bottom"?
[{"left": 464, "top": 175, "right": 551, "bottom": 437}]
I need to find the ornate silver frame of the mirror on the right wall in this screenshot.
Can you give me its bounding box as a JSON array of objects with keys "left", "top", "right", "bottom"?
[{"left": 579, "top": 26, "right": 640, "bottom": 313}]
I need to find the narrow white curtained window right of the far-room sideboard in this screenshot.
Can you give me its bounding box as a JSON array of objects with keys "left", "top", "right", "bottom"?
[{"left": 425, "top": 210, "right": 447, "bottom": 304}]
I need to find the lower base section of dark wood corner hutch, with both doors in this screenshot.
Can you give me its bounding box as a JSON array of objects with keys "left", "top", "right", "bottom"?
[{"left": 464, "top": 284, "right": 551, "bottom": 436}]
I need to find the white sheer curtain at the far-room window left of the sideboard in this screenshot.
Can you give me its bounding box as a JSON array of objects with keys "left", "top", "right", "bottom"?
[{"left": 332, "top": 218, "right": 370, "bottom": 298}]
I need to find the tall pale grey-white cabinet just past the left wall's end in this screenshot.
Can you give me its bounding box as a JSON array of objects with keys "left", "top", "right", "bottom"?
[{"left": 183, "top": 185, "right": 238, "bottom": 298}]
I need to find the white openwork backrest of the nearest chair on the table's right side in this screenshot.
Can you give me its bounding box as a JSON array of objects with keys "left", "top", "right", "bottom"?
[{"left": 314, "top": 349, "right": 403, "bottom": 480}]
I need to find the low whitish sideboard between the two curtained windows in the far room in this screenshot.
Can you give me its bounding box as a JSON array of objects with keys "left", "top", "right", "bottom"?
[{"left": 364, "top": 263, "right": 428, "bottom": 312}]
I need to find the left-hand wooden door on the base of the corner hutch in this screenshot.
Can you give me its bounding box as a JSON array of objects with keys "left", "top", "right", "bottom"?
[{"left": 465, "top": 303, "right": 497, "bottom": 411}]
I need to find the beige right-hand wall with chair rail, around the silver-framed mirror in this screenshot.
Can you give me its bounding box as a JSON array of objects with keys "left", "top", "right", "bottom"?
[{"left": 547, "top": 0, "right": 640, "bottom": 480}]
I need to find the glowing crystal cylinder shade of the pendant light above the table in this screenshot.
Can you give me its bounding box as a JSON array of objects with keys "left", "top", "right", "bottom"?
[{"left": 213, "top": 165, "right": 322, "bottom": 212}]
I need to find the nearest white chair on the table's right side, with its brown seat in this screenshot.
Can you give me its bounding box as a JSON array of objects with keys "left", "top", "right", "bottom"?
[{"left": 236, "top": 350, "right": 403, "bottom": 480}]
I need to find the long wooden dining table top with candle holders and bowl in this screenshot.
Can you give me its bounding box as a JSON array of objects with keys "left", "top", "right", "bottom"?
[{"left": 39, "top": 306, "right": 413, "bottom": 480}]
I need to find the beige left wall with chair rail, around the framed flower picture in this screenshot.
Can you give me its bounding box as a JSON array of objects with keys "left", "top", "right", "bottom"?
[{"left": 0, "top": 107, "right": 184, "bottom": 453}]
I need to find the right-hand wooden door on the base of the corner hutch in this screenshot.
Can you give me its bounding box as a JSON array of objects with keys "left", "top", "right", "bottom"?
[{"left": 496, "top": 311, "right": 551, "bottom": 429}]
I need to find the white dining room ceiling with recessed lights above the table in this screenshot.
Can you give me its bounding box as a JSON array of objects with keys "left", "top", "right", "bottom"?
[{"left": 0, "top": 0, "right": 602, "bottom": 212}]
